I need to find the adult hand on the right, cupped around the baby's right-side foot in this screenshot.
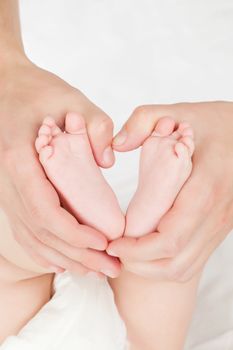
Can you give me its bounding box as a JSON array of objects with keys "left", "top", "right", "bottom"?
[{"left": 107, "top": 102, "right": 233, "bottom": 282}]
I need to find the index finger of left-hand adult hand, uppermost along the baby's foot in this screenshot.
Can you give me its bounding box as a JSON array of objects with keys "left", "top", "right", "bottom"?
[{"left": 13, "top": 157, "right": 107, "bottom": 250}]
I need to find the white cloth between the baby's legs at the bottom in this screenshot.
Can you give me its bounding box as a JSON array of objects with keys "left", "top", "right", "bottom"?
[{"left": 0, "top": 272, "right": 126, "bottom": 350}]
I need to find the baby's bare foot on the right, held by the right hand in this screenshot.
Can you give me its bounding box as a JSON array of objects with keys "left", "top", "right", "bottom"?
[{"left": 125, "top": 118, "right": 194, "bottom": 237}]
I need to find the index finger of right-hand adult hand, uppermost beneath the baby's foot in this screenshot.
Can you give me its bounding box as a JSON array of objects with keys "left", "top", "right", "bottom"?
[{"left": 107, "top": 174, "right": 208, "bottom": 261}]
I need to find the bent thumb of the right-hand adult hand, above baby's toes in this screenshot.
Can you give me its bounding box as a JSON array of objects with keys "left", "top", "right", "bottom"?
[{"left": 112, "top": 105, "right": 174, "bottom": 152}]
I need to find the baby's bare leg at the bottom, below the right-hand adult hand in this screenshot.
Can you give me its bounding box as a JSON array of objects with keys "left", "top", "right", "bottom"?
[{"left": 110, "top": 271, "right": 200, "bottom": 350}]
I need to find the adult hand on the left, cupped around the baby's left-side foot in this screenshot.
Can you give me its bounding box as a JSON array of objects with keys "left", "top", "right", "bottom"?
[{"left": 0, "top": 56, "right": 120, "bottom": 276}]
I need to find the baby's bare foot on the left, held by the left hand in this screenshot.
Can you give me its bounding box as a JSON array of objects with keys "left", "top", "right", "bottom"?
[{"left": 35, "top": 113, "right": 125, "bottom": 240}]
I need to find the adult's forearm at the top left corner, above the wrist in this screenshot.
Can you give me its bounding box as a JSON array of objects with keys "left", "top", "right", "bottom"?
[{"left": 0, "top": 0, "right": 24, "bottom": 64}]
